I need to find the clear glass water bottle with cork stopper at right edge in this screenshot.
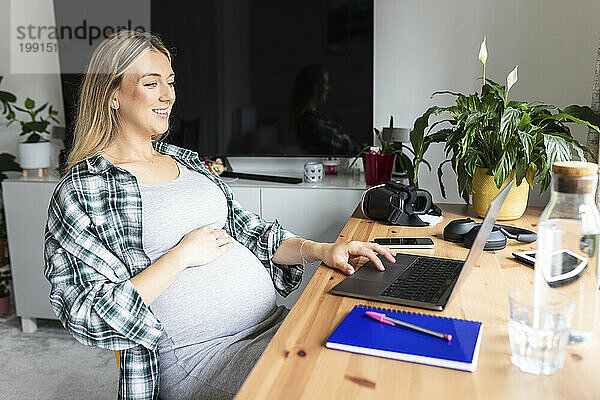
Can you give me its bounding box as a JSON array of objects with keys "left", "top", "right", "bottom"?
[{"left": 534, "top": 161, "right": 600, "bottom": 344}]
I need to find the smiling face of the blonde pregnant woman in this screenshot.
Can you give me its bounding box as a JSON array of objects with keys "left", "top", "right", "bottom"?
[{"left": 111, "top": 51, "right": 175, "bottom": 137}]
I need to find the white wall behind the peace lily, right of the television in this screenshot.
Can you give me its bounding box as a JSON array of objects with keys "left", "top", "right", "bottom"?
[{"left": 374, "top": 0, "right": 600, "bottom": 205}]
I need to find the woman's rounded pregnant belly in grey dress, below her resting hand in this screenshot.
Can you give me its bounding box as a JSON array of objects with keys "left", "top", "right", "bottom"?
[{"left": 150, "top": 241, "right": 275, "bottom": 347}]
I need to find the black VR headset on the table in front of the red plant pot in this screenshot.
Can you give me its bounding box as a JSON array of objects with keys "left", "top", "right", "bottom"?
[{"left": 361, "top": 181, "right": 442, "bottom": 226}]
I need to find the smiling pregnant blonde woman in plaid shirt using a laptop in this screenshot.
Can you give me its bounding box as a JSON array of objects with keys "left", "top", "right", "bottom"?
[{"left": 45, "top": 31, "right": 394, "bottom": 399}]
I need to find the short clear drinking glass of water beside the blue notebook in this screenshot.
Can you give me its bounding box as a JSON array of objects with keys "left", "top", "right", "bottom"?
[{"left": 508, "top": 288, "right": 575, "bottom": 375}]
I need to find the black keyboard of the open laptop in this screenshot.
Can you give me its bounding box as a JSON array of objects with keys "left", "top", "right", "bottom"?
[{"left": 381, "top": 257, "right": 464, "bottom": 303}]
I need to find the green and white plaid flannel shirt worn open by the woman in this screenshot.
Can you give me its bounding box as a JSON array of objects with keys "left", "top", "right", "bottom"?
[{"left": 44, "top": 141, "right": 303, "bottom": 399}]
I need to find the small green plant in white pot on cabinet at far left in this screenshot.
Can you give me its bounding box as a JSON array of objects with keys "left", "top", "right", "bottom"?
[{"left": 0, "top": 76, "right": 59, "bottom": 176}]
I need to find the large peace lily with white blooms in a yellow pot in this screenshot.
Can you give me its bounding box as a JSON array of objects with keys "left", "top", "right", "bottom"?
[{"left": 410, "top": 38, "right": 600, "bottom": 220}]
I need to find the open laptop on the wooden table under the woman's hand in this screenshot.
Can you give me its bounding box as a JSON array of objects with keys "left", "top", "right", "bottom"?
[{"left": 331, "top": 179, "right": 514, "bottom": 311}]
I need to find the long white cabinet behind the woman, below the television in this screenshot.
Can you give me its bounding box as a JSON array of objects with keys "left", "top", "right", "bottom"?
[{"left": 2, "top": 174, "right": 364, "bottom": 332}]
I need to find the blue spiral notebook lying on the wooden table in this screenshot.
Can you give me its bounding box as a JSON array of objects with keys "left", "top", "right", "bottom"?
[{"left": 325, "top": 306, "right": 483, "bottom": 372}]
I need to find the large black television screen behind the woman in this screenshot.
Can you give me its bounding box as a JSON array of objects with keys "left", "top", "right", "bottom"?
[{"left": 55, "top": 0, "right": 373, "bottom": 156}]
